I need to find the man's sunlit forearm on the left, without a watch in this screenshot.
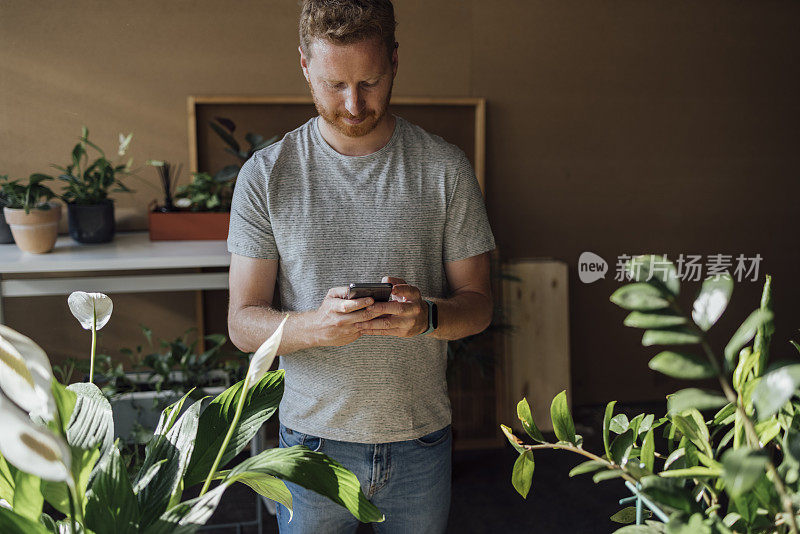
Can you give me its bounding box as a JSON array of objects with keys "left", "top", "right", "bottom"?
[{"left": 228, "top": 306, "right": 315, "bottom": 355}]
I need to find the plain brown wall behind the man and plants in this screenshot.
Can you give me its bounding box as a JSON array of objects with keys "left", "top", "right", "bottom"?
[{"left": 0, "top": 0, "right": 800, "bottom": 403}]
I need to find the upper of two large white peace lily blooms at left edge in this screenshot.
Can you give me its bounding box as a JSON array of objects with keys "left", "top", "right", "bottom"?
[{"left": 0, "top": 325, "right": 56, "bottom": 420}]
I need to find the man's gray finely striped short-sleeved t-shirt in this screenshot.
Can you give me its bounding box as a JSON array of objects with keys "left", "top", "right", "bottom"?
[{"left": 228, "top": 117, "right": 495, "bottom": 443}]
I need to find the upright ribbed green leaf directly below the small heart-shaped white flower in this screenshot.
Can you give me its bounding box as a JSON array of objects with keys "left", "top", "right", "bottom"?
[{"left": 67, "top": 382, "right": 114, "bottom": 457}]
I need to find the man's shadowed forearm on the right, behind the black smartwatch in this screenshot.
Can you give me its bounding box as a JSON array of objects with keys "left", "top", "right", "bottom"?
[{"left": 429, "top": 291, "right": 493, "bottom": 340}]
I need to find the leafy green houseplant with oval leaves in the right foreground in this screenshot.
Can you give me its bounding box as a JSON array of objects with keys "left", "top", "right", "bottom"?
[{"left": 502, "top": 256, "right": 800, "bottom": 534}]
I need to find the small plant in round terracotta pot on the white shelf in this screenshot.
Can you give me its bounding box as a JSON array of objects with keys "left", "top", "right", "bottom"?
[{"left": 0, "top": 173, "right": 61, "bottom": 254}]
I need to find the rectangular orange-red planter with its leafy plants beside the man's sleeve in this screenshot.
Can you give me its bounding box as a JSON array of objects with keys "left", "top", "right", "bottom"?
[{"left": 147, "top": 117, "right": 278, "bottom": 241}]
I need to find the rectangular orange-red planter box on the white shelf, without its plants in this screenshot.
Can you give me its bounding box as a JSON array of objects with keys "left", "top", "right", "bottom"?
[{"left": 149, "top": 211, "right": 231, "bottom": 241}]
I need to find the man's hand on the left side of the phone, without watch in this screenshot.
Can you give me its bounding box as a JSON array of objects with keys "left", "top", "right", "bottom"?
[{"left": 312, "top": 287, "right": 376, "bottom": 347}]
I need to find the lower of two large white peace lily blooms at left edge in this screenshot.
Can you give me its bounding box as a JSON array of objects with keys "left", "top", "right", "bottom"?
[{"left": 0, "top": 395, "right": 72, "bottom": 482}]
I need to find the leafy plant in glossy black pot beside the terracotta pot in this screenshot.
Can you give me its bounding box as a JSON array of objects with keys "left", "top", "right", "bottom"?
[{"left": 53, "top": 126, "right": 133, "bottom": 243}]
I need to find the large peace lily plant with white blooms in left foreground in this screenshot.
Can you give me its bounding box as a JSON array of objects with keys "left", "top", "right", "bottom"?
[{"left": 0, "top": 293, "right": 383, "bottom": 534}]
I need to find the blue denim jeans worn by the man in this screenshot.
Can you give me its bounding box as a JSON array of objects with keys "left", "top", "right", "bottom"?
[{"left": 278, "top": 425, "right": 453, "bottom": 534}]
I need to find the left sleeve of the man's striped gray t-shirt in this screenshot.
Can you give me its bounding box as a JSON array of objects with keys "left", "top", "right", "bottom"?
[{"left": 228, "top": 156, "right": 279, "bottom": 260}]
